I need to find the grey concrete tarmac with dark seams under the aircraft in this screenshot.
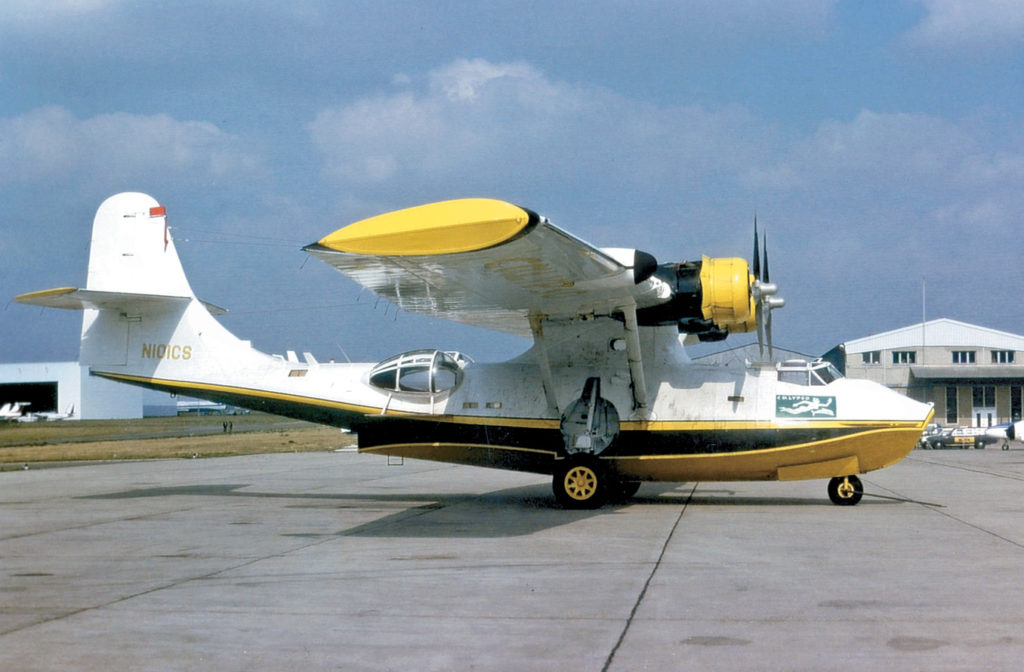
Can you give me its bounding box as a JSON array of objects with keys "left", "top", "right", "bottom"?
[{"left": 0, "top": 444, "right": 1024, "bottom": 672}]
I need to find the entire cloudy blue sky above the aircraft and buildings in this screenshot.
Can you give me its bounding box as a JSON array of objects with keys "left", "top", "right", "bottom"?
[{"left": 0, "top": 0, "right": 1024, "bottom": 362}]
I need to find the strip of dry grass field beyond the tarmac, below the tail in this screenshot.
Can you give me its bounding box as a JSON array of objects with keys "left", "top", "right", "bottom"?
[{"left": 0, "top": 413, "right": 355, "bottom": 470}]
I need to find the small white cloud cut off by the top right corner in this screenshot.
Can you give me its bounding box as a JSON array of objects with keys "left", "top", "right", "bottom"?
[{"left": 907, "top": 0, "right": 1024, "bottom": 51}]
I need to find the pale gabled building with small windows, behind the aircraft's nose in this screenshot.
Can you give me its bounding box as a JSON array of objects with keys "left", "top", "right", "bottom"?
[{"left": 824, "top": 318, "right": 1024, "bottom": 427}]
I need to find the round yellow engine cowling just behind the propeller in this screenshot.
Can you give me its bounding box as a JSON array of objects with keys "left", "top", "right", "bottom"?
[{"left": 700, "top": 256, "right": 757, "bottom": 333}]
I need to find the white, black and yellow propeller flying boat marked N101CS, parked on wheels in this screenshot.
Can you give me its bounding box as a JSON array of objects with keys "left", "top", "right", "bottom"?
[{"left": 15, "top": 194, "right": 932, "bottom": 508}]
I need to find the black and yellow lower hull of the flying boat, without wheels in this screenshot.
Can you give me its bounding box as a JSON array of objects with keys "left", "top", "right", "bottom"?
[{"left": 97, "top": 373, "right": 932, "bottom": 481}]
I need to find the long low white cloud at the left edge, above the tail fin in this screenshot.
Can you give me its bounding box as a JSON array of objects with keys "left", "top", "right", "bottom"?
[{"left": 0, "top": 106, "right": 259, "bottom": 183}]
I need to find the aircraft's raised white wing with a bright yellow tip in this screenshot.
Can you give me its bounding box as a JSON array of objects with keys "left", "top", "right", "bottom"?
[{"left": 304, "top": 199, "right": 671, "bottom": 336}]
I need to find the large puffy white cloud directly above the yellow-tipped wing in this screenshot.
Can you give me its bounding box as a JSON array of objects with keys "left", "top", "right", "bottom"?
[{"left": 308, "top": 59, "right": 768, "bottom": 204}]
